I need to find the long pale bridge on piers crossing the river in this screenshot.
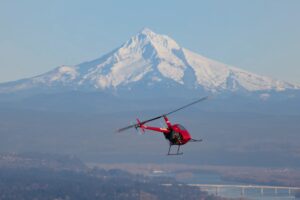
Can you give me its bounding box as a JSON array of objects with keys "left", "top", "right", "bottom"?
[{"left": 187, "top": 184, "right": 300, "bottom": 196}]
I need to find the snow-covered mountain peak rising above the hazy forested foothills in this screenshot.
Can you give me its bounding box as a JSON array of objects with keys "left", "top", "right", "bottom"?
[{"left": 0, "top": 29, "right": 300, "bottom": 93}]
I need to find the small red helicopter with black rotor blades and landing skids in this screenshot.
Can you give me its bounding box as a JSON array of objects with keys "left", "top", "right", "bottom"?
[{"left": 118, "top": 97, "right": 208, "bottom": 155}]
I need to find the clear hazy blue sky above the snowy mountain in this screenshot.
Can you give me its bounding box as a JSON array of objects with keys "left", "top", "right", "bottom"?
[{"left": 0, "top": 0, "right": 300, "bottom": 83}]
